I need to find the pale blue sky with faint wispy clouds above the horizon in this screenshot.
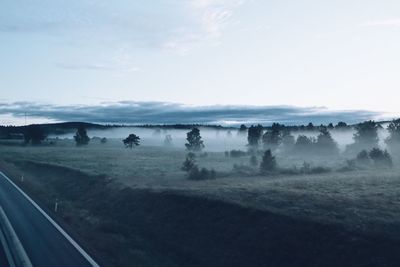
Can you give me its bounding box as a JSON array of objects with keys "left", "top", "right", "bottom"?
[{"left": 0, "top": 0, "right": 400, "bottom": 124}]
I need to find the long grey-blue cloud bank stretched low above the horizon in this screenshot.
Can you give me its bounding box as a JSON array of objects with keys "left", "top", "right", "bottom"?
[{"left": 0, "top": 101, "right": 383, "bottom": 125}]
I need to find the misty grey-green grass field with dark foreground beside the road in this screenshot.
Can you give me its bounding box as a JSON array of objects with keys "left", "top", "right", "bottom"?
[{"left": 0, "top": 140, "right": 400, "bottom": 266}]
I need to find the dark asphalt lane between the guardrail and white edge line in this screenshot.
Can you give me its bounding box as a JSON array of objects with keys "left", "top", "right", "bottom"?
[{"left": 0, "top": 173, "right": 96, "bottom": 267}]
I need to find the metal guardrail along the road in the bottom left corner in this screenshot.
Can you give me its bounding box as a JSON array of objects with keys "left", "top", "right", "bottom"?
[{"left": 0, "top": 207, "right": 33, "bottom": 267}]
